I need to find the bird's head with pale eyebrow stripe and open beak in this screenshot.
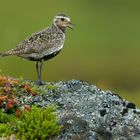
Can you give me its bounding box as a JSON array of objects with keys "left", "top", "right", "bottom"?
[{"left": 53, "top": 14, "right": 74, "bottom": 30}]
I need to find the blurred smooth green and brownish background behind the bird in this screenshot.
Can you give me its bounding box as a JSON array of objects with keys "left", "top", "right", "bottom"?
[{"left": 0, "top": 0, "right": 140, "bottom": 106}]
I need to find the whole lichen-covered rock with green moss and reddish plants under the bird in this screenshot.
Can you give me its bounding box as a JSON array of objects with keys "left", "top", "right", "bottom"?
[{"left": 0, "top": 77, "right": 140, "bottom": 140}]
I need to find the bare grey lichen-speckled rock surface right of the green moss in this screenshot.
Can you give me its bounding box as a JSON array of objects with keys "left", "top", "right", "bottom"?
[{"left": 30, "top": 80, "right": 140, "bottom": 140}]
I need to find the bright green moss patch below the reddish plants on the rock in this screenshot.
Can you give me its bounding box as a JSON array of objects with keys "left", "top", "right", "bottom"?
[{"left": 0, "top": 106, "right": 62, "bottom": 140}]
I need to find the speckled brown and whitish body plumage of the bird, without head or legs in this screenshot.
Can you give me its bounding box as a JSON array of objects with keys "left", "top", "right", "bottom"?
[{"left": 3, "top": 22, "right": 65, "bottom": 61}]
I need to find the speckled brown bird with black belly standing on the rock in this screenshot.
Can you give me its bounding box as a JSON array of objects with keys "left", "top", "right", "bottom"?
[{"left": 0, "top": 13, "right": 74, "bottom": 85}]
